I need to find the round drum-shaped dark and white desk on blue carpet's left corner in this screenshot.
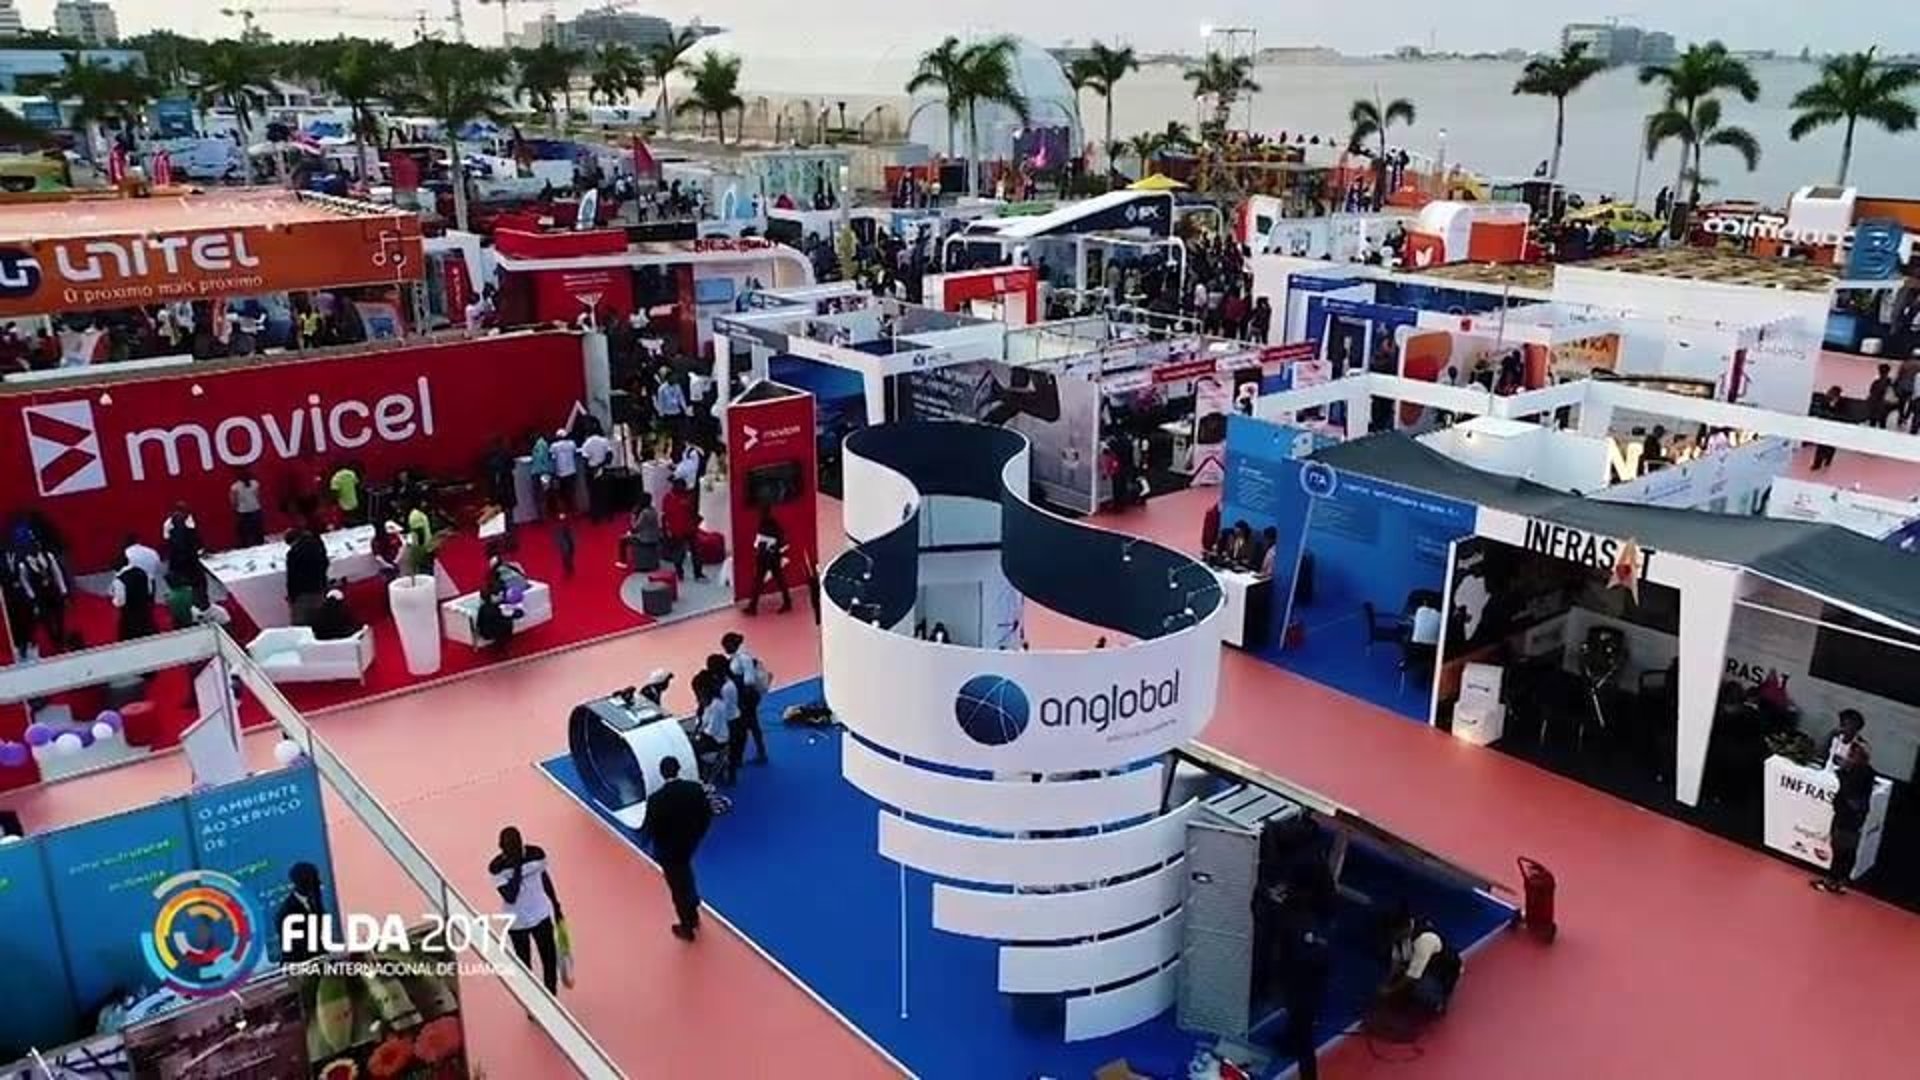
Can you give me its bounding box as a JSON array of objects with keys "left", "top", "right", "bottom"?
[{"left": 566, "top": 684, "right": 699, "bottom": 828}]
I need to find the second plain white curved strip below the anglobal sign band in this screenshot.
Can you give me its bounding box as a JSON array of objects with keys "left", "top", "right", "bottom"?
[{"left": 879, "top": 803, "right": 1194, "bottom": 886}]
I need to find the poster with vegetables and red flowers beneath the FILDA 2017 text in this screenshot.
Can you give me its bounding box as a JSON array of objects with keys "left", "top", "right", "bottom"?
[{"left": 294, "top": 930, "right": 468, "bottom": 1080}]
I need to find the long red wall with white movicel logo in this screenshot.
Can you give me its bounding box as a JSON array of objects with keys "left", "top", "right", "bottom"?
[{"left": 0, "top": 332, "right": 586, "bottom": 573}]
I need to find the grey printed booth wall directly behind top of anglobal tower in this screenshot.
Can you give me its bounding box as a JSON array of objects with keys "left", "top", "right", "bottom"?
[{"left": 895, "top": 361, "right": 1100, "bottom": 513}]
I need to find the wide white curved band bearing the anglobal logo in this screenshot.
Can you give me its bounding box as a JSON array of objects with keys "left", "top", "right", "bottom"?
[{"left": 820, "top": 591, "right": 1221, "bottom": 773}]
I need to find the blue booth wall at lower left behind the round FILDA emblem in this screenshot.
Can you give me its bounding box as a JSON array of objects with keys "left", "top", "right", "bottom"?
[{"left": 0, "top": 765, "right": 334, "bottom": 1061}]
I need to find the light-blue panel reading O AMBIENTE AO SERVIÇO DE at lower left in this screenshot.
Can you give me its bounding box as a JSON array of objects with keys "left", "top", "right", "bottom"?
[{"left": 186, "top": 763, "right": 338, "bottom": 959}]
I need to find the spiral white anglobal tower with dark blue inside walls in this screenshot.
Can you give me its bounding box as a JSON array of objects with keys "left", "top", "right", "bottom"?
[{"left": 822, "top": 423, "right": 1221, "bottom": 1040}]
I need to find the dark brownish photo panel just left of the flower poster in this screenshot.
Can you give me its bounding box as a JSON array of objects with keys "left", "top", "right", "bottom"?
[{"left": 127, "top": 976, "right": 307, "bottom": 1080}]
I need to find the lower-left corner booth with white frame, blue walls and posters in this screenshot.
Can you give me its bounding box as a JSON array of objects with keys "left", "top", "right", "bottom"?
[{"left": 0, "top": 626, "right": 618, "bottom": 1080}]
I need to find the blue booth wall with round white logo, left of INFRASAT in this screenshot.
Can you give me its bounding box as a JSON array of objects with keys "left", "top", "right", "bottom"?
[{"left": 1219, "top": 417, "right": 1476, "bottom": 723}]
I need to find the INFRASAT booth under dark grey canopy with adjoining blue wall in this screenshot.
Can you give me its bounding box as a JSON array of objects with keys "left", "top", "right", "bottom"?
[{"left": 1221, "top": 417, "right": 1920, "bottom": 907}]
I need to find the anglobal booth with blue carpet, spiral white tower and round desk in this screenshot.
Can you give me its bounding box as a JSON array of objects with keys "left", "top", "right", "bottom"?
[{"left": 545, "top": 423, "right": 1515, "bottom": 1078}]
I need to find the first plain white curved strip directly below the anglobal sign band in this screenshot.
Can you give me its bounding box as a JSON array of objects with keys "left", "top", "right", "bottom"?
[{"left": 841, "top": 738, "right": 1165, "bottom": 832}]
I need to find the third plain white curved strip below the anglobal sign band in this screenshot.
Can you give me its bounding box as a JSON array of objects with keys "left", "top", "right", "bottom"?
[{"left": 933, "top": 859, "right": 1187, "bottom": 942}]
